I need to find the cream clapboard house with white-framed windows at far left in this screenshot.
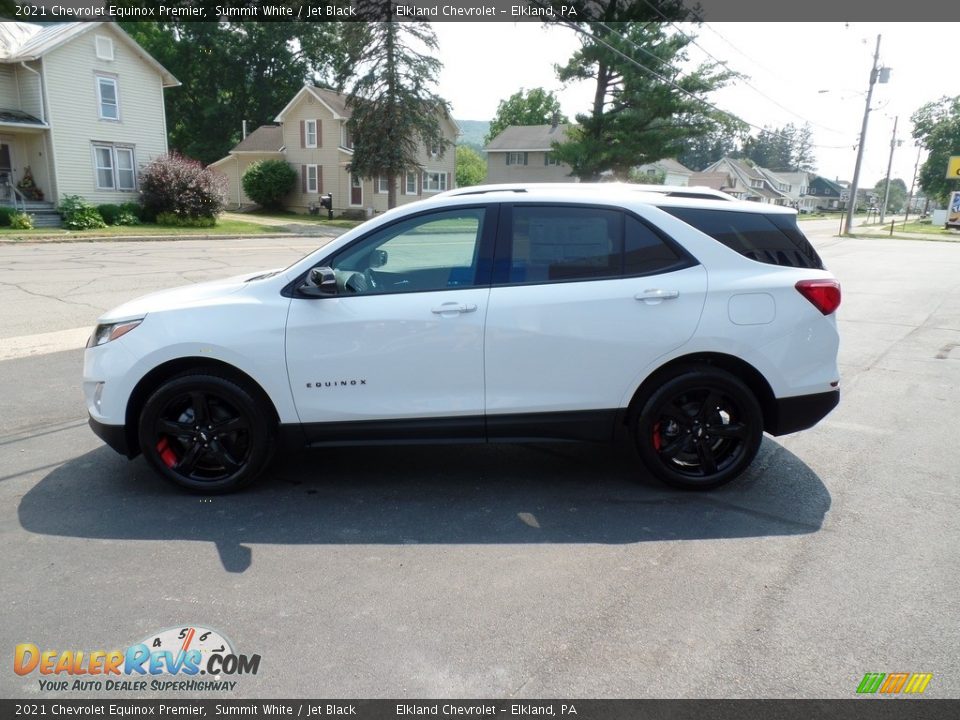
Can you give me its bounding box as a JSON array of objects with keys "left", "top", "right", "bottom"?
[{"left": 0, "top": 22, "right": 180, "bottom": 215}]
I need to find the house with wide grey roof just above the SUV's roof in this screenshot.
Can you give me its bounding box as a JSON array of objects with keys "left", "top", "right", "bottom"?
[{"left": 484, "top": 124, "right": 578, "bottom": 184}]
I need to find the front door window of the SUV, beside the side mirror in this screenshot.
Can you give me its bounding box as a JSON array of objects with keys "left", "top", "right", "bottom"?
[{"left": 331, "top": 208, "right": 484, "bottom": 295}]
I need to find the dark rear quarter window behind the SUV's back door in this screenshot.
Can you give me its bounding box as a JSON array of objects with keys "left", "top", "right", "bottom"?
[{"left": 661, "top": 207, "right": 823, "bottom": 269}]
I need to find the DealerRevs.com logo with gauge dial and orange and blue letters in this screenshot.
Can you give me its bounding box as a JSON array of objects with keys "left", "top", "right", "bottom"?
[{"left": 13, "top": 625, "right": 260, "bottom": 692}]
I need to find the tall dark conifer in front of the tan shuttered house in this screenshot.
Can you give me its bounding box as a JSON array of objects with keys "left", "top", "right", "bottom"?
[{"left": 339, "top": 21, "right": 449, "bottom": 208}]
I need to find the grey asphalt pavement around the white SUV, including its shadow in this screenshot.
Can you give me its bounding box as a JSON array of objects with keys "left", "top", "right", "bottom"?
[{"left": 0, "top": 229, "right": 960, "bottom": 699}]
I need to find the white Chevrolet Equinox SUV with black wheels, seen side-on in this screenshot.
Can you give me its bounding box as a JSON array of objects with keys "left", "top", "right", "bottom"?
[{"left": 83, "top": 185, "right": 840, "bottom": 493}]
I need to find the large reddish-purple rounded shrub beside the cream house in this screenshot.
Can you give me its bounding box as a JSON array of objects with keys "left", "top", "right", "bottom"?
[{"left": 140, "top": 154, "right": 227, "bottom": 219}]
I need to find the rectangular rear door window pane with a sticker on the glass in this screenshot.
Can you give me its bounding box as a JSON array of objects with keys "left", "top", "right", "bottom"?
[{"left": 509, "top": 205, "right": 622, "bottom": 283}]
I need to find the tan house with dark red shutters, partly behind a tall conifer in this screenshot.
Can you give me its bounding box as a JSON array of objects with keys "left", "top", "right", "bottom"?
[{"left": 210, "top": 85, "right": 460, "bottom": 214}]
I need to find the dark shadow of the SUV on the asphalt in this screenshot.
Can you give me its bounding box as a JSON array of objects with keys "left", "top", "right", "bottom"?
[{"left": 18, "top": 438, "right": 830, "bottom": 572}]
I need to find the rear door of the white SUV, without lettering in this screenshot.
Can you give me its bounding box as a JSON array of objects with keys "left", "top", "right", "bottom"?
[{"left": 485, "top": 203, "right": 707, "bottom": 439}]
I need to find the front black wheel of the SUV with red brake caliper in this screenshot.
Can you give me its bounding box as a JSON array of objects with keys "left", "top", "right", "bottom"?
[{"left": 138, "top": 371, "right": 275, "bottom": 495}]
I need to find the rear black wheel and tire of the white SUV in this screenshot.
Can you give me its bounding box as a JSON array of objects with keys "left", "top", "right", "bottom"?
[{"left": 630, "top": 365, "right": 763, "bottom": 490}]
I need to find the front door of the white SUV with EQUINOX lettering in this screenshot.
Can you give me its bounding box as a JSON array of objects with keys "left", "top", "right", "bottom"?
[{"left": 286, "top": 205, "right": 496, "bottom": 443}]
